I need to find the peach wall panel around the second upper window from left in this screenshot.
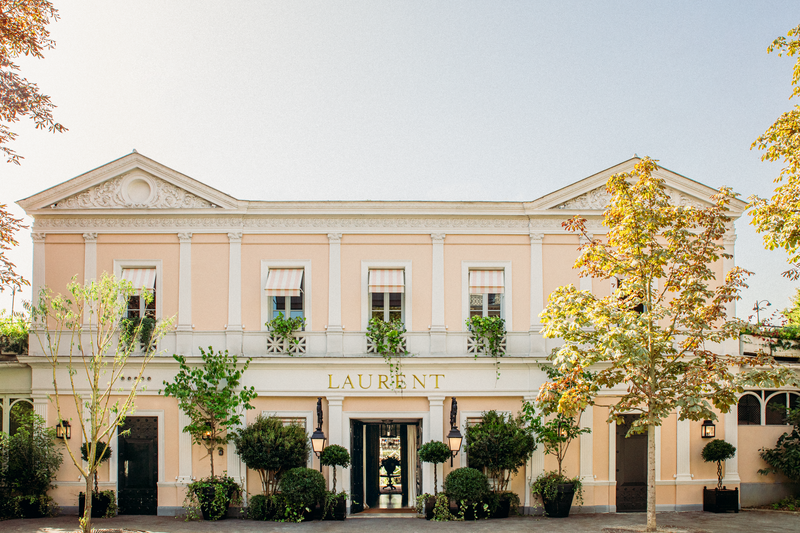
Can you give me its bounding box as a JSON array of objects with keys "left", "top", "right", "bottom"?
[{"left": 242, "top": 235, "right": 332, "bottom": 331}]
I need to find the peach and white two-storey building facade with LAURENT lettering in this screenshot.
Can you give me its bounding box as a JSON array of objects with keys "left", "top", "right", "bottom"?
[{"left": 0, "top": 152, "right": 797, "bottom": 514}]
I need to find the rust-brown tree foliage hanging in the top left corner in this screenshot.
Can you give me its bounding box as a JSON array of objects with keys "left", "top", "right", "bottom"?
[{"left": 0, "top": 0, "right": 66, "bottom": 164}]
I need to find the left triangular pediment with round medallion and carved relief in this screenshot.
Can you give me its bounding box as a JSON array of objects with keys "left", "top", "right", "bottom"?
[{"left": 18, "top": 152, "right": 239, "bottom": 214}]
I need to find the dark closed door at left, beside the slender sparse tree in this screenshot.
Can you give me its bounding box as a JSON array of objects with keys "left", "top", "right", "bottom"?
[{"left": 117, "top": 416, "right": 158, "bottom": 515}]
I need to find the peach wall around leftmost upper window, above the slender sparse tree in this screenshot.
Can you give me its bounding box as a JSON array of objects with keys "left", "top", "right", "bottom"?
[{"left": 97, "top": 233, "right": 180, "bottom": 317}]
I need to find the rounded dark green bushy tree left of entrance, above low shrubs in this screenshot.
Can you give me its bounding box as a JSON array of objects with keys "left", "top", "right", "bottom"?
[{"left": 233, "top": 415, "right": 310, "bottom": 496}]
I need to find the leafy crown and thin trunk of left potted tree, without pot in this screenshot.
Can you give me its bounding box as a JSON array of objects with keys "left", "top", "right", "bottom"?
[{"left": 164, "top": 348, "right": 258, "bottom": 478}]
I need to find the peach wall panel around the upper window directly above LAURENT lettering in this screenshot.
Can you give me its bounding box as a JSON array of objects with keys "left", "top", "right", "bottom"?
[{"left": 342, "top": 235, "right": 433, "bottom": 331}]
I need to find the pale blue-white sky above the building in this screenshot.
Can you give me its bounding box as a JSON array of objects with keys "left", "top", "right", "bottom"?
[{"left": 0, "top": 0, "right": 800, "bottom": 318}]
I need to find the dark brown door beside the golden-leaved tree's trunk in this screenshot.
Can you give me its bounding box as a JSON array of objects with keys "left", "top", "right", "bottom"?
[{"left": 617, "top": 415, "right": 647, "bottom": 513}]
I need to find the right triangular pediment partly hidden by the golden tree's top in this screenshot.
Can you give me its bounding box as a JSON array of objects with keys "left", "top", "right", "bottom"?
[{"left": 530, "top": 157, "right": 746, "bottom": 215}]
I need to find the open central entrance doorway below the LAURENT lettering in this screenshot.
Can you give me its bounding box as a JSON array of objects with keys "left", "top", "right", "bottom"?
[{"left": 350, "top": 420, "right": 421, "bottom": 513}]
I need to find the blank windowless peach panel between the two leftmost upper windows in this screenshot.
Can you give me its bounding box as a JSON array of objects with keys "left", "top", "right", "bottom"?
[{"left": 192, "top": 233, "right": 230, "bottom": 332}]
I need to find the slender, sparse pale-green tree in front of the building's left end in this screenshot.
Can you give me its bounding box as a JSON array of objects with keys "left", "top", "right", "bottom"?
[{"left": 31, "top": 273, "right": 173, "bottom": 533}]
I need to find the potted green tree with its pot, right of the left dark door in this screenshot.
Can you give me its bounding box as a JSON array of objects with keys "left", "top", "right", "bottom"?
[{"left": 159, "top": 346, "right": 257, "bottom": 520}]
